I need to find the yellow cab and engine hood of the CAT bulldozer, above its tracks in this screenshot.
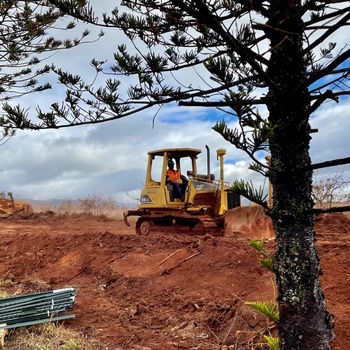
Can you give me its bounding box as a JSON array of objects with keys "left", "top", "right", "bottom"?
[{"left": 139, "top": 148, "right": 225, "bottom": 215}]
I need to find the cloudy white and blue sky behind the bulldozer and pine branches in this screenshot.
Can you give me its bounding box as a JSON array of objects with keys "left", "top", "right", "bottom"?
[{"left": 0, "top": 0, "right": 350, "bottom": 204}]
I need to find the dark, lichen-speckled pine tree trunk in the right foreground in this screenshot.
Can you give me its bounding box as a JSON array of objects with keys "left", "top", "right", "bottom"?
[{"left": 267, "top": 0, "right": 333, "bottom": 350}]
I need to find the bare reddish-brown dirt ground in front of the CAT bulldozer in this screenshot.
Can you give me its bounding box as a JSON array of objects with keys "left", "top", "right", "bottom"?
[{"left": 0, "top": 214, "right": 350, "bottom": 350}]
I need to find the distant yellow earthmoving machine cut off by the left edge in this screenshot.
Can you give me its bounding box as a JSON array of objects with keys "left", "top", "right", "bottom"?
[{"left": 0, "top": 192, "right": 34, "bottom": 219}]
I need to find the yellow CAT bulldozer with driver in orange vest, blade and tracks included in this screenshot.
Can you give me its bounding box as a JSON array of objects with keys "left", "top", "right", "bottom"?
[{"left": 123, "top": 146, "right": 273, "bottom": 238}]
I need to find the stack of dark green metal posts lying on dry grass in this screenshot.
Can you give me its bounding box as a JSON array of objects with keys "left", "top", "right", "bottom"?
[{"left": 0, "top": 288, "right": 76, "bottom": 330}]
